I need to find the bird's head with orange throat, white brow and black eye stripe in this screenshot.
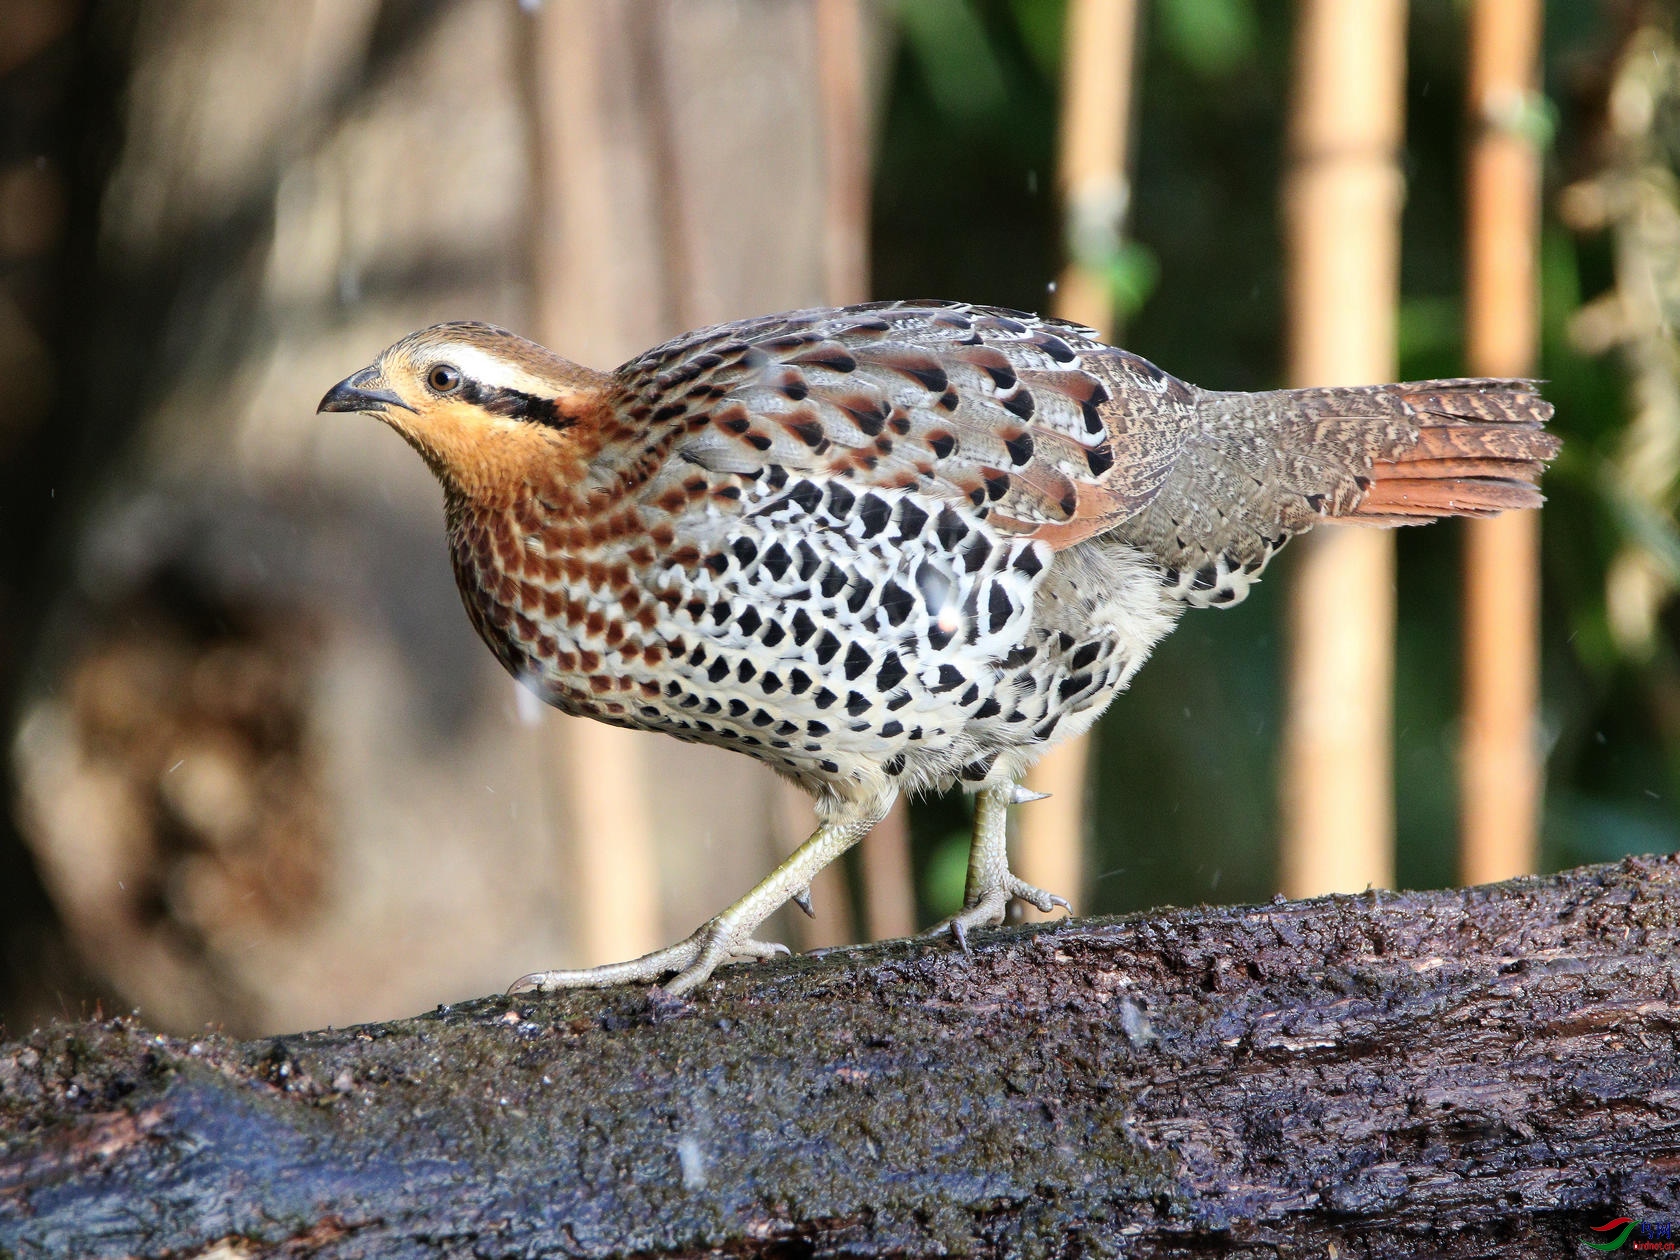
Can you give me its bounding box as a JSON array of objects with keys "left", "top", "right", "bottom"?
[{"left": 316, "top": 323, "right": 612, "bottom": 506}]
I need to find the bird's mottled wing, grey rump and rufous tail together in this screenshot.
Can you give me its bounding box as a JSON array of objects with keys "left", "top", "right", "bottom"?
[{"left": 618, "top": 302, "right": 1556, "bottom": 577}]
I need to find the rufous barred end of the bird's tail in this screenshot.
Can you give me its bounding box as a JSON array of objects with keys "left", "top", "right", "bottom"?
[{"left": 1344, "top": 380, "right": 1562, "bottom": 526}]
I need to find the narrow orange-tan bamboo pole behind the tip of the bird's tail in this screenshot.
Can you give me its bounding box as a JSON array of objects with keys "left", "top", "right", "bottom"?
[{"left": 1460, "top": 0, "right": 1542, "bottom": 884}]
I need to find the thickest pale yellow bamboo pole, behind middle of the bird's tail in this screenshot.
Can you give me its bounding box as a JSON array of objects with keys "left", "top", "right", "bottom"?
[{"left": 1278, "top": 0, "right": 1406, "bottom": 897}]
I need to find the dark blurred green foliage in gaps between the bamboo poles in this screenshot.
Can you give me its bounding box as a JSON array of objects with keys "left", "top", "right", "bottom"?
[{"left": 874, "top": 0, "right": 1680, "bottom": 916}]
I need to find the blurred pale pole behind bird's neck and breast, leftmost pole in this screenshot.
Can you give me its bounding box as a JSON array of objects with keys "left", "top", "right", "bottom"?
[{"left": 533, "top": 0, "right": 660, "bottom": 964}]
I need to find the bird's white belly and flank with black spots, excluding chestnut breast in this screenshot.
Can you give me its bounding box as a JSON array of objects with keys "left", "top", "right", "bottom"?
[{"left": 510, "top": 479, "right": 1183, "bottom": 793}]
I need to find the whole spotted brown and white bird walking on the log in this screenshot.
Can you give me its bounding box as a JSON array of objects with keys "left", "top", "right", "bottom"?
[{"left": 319, "top": 301, "right": 1559, "bottom": 995}]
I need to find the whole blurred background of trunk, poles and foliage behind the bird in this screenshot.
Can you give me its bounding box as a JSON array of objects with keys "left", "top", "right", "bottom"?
[{"left": 0, "top": 0, "right": 1680, "bottom": 1035}]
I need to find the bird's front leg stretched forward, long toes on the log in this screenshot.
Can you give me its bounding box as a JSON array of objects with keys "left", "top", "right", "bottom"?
[{"left": 507, "top": 788, "right": 897, "bottom": 995}]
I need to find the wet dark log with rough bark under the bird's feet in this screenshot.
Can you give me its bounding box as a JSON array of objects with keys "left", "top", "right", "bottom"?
[{"left": 0, "top": 858, "right": 1680, "bottom": 1257}]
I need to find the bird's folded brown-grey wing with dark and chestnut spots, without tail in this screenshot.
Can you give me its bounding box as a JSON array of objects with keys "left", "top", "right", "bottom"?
[{"left": 618, "top": 302, "right": 1194, "bottom": 546}]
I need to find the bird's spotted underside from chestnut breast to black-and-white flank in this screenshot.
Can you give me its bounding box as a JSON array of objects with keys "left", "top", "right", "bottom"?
[{"left": 455, "top": 467, "right": 1155, "bottom": 790}]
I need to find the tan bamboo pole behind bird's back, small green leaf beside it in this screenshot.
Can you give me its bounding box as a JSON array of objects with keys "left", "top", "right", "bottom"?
[{"left": 1016, "top": 0, "right": 1137, "bottom": 919}]
